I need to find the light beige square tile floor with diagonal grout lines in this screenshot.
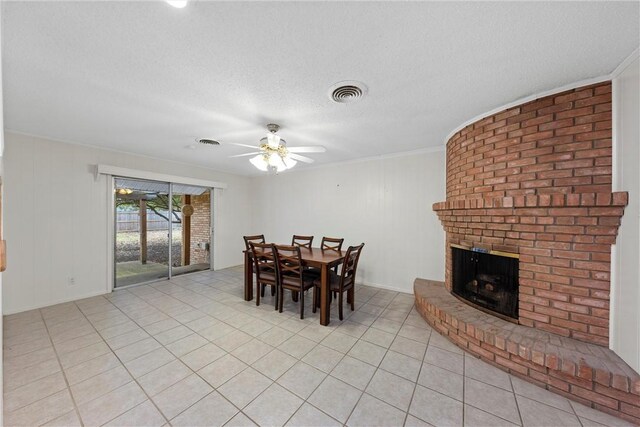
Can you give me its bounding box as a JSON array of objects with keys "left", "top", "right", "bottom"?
[{"left": 4, "top": 267, "right": 626, "bottom": 426}]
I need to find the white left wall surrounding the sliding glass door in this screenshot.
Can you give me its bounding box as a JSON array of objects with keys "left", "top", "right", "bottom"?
[{"left": 3, "top": 132, "right": 251, "bottom": 314}]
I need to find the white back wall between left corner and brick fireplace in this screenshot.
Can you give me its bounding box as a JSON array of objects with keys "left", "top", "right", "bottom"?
[{"left": 252, "top": 151, "right": 445, "bottom": 292}]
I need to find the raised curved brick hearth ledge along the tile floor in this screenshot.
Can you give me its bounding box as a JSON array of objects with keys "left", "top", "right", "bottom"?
[{"left": 414, "top": 279, "right": 640, "bottom": 425}]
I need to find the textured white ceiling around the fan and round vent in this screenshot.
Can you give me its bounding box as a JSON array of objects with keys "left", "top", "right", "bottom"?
[{"left": 1, "top": 1, "right": 640, "bottom": 175}]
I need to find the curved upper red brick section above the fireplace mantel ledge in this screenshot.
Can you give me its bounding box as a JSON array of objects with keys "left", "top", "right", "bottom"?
[{"left": 447, "top": 82, "right": 611, "bottom": 200}]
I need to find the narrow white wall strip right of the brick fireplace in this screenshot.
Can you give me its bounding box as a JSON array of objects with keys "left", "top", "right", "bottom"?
[{"left": 610, "top": 50, "right": 640, "bottom": 372}]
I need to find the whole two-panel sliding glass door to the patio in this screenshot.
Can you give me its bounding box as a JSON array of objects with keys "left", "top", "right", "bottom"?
[{"left": 114, "top": 178, "right": 211, "bottom": 288}]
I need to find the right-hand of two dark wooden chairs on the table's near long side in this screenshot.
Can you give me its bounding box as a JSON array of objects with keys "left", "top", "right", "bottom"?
[{"left": 274, "top": 245, "right": 316, "bottom": 319}]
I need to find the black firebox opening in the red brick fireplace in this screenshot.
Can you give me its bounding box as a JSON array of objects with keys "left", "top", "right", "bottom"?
[{"left": 451, "top": 247, "right": 518, "bottom": 320}]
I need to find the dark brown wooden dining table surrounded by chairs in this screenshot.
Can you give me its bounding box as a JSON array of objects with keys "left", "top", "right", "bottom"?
[{"left": 244, "top": 247, "right": 346, "bottom": 326}]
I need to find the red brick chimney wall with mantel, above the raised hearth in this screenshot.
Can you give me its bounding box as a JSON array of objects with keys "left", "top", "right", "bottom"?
[{"left": 433, "top": 82, "right": 627, "bottom": 346}]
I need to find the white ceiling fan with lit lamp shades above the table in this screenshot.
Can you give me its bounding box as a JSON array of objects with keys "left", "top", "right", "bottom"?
[{"left": 230, "top": 123, "right": 327, "bottom": 172}]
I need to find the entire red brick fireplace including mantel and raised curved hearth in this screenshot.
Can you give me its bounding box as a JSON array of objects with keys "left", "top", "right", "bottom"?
[{"left": 416, "top": 82, "right": 640, "bottom": 422}]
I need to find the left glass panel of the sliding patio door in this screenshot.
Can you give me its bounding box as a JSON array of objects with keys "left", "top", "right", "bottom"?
[{"left": 114, "top": 178, "right": 170, "bottom": 288}]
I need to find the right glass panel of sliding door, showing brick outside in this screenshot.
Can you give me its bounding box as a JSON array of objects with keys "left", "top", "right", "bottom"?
[{"left": 171, "top": 184, "right": 211, "bottom": 276}]
